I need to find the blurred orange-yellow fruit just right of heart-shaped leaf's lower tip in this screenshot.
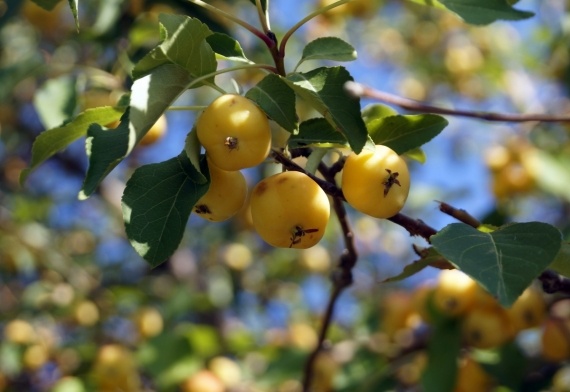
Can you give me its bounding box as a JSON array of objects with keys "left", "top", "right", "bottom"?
[{"left": 507, "top": 287, "right": 546, "bottom": 331}]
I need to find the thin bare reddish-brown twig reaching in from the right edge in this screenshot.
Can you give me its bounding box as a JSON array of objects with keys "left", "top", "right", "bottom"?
[{"left": 345, "top": 82, "right": 570, "bottom": 122}]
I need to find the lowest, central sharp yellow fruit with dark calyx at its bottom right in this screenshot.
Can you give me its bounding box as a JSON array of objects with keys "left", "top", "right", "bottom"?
[{"left": 251, "top": 171, "right": 330, "bottom": 249}]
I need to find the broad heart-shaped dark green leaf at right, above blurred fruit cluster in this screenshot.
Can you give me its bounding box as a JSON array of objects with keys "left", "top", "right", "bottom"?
[{"left": 431, "top": 222, "right": 562, "bottom": 307}]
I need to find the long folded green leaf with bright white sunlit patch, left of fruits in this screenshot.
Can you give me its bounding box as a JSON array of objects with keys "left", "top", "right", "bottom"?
[{"left": 79, "top": 64, "right": 192, "bottom": 199}]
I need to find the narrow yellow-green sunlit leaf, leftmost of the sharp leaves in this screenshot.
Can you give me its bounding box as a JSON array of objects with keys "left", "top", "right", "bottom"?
[{"left": 20, "top": 106, "right": 124, "bottom": 183}]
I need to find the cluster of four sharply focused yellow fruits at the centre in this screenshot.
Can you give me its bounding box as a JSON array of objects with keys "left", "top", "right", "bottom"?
[{"left": 194, "top": 94, "right": 410, "bottom": 249}]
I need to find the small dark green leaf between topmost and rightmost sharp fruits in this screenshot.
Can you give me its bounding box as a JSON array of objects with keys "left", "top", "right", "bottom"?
[{"left": 288, "top": 117, "right": 347, "bottom": 148}]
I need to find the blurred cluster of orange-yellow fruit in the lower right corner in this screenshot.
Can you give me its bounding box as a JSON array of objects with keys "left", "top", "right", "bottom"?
[{"left": 382, "top": 270, "right": 570, "bottom": 392}]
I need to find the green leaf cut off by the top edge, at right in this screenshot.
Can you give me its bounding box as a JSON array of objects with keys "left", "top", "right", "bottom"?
[{"left": 439, "top": 0, "right": 534, "bottom": 25}]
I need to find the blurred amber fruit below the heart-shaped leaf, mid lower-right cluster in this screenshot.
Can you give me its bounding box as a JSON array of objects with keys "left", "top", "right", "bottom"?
[{"left": 462, "top": 306, "right": 514, "bottom": 349}]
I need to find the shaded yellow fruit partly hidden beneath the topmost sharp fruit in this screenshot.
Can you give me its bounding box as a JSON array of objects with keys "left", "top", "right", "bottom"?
[{"left": 194, "top": 160, "right": 247, "bottom": 222}]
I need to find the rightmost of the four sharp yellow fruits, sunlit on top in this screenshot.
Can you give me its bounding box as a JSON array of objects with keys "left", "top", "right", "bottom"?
[{"left": 342, "top": 145, "right": 410, "bottom": 218}]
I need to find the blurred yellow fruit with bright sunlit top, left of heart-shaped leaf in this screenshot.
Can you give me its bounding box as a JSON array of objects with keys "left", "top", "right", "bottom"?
[{"left": 433, "top": 269, "right": 478, "bottom": 317}]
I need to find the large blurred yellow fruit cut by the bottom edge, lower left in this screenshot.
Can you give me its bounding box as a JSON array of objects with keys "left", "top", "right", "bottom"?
[{"left": 93, "top": 344, "right": 141, "bottom": 392}]
